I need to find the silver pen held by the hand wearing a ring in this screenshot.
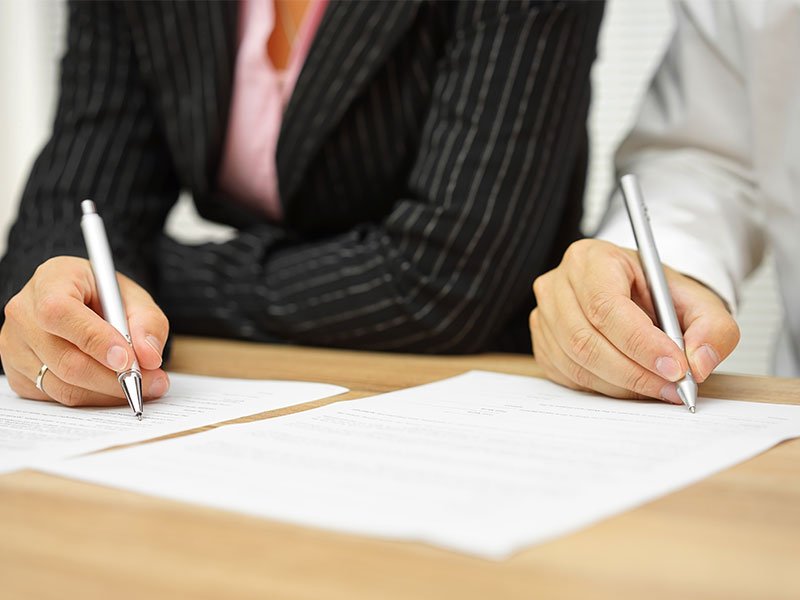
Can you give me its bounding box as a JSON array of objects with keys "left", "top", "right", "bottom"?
[{"left": 81, "top": 200, "right": 142, "bottom": 421}]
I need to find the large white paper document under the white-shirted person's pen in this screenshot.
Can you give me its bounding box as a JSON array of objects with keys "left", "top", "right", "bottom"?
[{"left": 42, "top": 371, "right": 800, "bottom": 558}]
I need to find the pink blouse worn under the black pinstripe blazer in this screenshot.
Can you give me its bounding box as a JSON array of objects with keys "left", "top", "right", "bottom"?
[{"left": 218, "top": 0, "right": 328, "bottom": 221}]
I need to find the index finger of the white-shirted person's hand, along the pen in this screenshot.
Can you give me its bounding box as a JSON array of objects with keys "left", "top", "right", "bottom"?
[{"left": 568, "top": 247, "right": 689, "bottom": 380}]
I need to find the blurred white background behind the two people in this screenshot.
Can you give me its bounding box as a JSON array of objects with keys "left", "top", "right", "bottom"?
[{"left": 0, "top": 0, "right": 781, "bottom": 374}]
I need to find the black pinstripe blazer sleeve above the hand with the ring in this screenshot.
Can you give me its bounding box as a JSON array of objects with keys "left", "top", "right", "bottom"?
[{"left": 0, "top": 2, "right": 178, "bottom": 324}]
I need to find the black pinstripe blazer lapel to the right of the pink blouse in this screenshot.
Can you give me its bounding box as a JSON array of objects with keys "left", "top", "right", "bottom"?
[{"left": 277, "top": 0, "right": 419, "bottom": 204}]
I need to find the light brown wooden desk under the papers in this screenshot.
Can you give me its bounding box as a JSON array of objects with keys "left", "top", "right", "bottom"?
[{"left": 0, "top": 339, "right": 800, "bottom": 599}]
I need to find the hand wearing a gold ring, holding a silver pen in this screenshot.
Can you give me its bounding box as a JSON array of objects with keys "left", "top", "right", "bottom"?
[{"left": 0, "top": 256, "right": 169, "bottom": 406}]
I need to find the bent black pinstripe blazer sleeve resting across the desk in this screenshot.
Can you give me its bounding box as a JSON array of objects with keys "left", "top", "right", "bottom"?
[{"left": 159, "top": 2, "right": 603, "bottom": 353}]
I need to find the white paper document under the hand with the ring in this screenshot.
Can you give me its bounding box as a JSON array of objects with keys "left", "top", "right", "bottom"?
[{"left": 0, "top": 373, "right": 347, "bottom": 473}]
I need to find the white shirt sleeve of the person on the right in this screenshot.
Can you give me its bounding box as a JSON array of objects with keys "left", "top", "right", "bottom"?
[{"left": 598, "top": 2, "right": 764, "bottom": 309}]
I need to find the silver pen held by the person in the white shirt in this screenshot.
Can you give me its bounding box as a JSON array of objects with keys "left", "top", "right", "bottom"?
[{"left": 620, "top": 175, "right": 697, "bottom": 412}]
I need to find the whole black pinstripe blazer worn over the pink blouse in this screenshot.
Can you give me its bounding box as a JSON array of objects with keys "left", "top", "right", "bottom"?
[{"left": 0, "top": 1, "right": 602, "bottom": 352}]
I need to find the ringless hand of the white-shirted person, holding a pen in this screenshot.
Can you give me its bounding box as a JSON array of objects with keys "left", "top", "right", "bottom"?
[{"left": 530, "top": 240, "right": 739, "bottom": 404}]
